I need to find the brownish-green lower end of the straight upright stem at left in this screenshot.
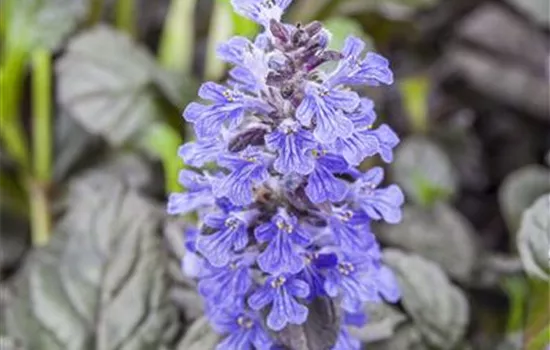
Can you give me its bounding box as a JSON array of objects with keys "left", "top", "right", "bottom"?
[{"left": 28, "top": 180, "right": 51, "bottom": 247}]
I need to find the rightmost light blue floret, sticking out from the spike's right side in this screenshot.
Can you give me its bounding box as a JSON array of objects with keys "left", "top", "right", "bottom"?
[{"left": 352, "top": 167, "right": 405, "bottom": 224}]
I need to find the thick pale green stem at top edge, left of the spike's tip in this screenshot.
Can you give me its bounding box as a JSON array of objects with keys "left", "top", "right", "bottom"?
[{"left": 158, "top": 0, "right": 197, "bottom": 74}]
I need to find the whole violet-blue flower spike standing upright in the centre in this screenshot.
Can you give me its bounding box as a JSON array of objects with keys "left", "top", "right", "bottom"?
[{"left": 168, "top": 0, "right": 404, "bottom": 350}]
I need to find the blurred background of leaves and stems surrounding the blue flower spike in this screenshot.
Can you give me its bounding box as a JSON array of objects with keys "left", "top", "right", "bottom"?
[{"left": 0, "top": 0, "right": 550, "bottom": 350}]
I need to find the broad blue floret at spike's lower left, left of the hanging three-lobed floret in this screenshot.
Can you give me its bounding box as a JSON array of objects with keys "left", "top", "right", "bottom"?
[{"left": 198, "top": 253, "right": 254, "bottom": 307}]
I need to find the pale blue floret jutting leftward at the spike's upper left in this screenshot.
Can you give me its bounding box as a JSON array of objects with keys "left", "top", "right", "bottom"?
[{"left": 183, "top": 82, "right": 272, "bottom": 138}]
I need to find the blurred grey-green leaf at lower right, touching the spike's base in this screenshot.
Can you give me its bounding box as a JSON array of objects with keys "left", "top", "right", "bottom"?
[{"left": 383, "top": 249, "right": 470, "bottom": 349}]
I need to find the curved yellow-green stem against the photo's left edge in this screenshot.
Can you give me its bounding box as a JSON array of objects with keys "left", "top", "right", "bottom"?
[{"left": 0, "top": 49, "right": 30, "bottom": 169}]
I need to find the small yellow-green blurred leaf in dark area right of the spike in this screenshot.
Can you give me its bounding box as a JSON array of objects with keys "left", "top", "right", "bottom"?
[{"left": 398, "top": 75, "right": 430, "bottom": 133}]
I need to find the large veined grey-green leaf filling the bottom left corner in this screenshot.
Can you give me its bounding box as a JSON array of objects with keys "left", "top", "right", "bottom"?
[{"left": 5, "top": 172, "right": 179, "bottom": 350}]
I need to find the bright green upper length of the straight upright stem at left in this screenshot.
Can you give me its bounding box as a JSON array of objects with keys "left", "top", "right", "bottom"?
[{"left": 32, "top": 49, "right": 52, "bottom": 184}]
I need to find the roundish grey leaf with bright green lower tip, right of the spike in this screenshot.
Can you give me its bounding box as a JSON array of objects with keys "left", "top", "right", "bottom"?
[{"left": 391, "top": 136, "right": 458, "bottom": 207}]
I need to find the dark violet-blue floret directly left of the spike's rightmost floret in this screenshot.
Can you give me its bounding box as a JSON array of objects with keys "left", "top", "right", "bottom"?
[{"left": 305, "top": 151, "right": 348, "bottom": 203}]
